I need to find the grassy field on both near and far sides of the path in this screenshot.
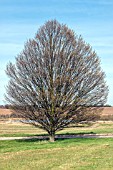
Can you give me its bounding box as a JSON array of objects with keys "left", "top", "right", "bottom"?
[{"left": 0, "top": 122, "right": 113, "bottom": 170}]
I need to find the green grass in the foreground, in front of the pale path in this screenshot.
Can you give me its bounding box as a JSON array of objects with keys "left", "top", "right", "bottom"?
[{"left": 0, "top": 138, "right": 113, "bottom": 170}]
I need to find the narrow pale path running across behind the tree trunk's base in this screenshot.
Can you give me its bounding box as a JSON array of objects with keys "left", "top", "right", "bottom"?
[{"left": 0, "top": 134, "right": 113, "bottom": 140}]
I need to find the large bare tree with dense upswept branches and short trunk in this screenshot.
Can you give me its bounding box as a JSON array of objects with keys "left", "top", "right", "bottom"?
[{"left": 6, "top": 20, "right": 108, "bottom": 141}]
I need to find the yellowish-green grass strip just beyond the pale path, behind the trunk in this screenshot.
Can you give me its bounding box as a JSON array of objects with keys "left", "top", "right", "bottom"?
[{"left": 0, "top": 121, "right": 113, "bottom": 137}]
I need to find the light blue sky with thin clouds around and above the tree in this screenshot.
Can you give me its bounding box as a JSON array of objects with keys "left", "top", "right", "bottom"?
[{"left": 0, "top": 0, "right": 113, "bottom": 105}]
